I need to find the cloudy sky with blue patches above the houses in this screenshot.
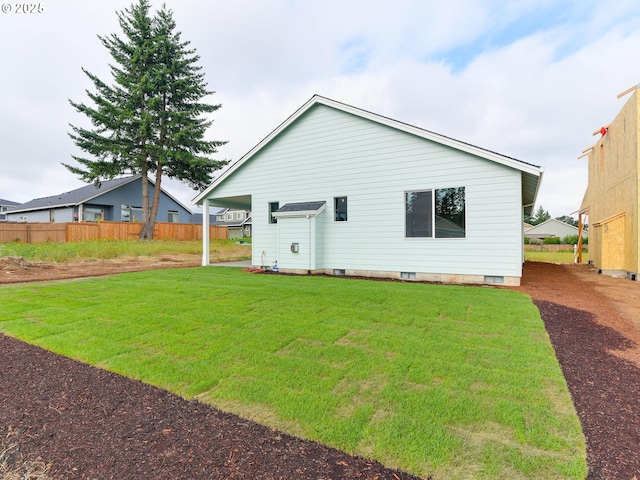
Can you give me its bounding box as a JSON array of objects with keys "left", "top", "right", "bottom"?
[{"left": 0, "top": 0, "right": 640, "bottom": 217}]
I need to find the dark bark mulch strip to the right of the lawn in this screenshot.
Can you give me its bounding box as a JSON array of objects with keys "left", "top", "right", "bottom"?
[{"left": 534, "top": 300, "right": 640, "bottom": 480}]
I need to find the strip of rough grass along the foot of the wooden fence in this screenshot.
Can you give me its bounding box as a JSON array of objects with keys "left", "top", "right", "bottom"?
[{"left": 0, "top": 240, "right": 251, "bottom": 263}]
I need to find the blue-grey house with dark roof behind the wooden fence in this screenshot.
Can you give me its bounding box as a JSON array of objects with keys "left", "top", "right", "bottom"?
[{"left": 6, "top": 175, "right": 192, "bottom": 223}]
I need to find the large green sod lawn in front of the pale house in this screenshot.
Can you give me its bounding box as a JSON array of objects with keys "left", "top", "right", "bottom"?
[{"left": 0, "top": 267, "right": 586, "bottom": 479}]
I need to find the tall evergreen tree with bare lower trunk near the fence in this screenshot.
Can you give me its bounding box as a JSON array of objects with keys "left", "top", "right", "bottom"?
[{"left": 63, "top": 0, "right": 227, "bottom": 239}]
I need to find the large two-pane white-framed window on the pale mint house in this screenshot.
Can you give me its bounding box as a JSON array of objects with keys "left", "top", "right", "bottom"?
[{"left": 404, "top": 187, "right": 466, "bottom": 238}]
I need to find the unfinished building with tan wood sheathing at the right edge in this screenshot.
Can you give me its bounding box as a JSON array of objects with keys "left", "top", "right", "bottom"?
[{"left": 580, "top": 89, "right": 640, "bottom": 279}]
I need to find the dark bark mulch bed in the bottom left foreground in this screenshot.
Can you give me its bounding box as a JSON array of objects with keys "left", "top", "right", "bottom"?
[{"left": 0, "top": 335, "right": 417, "bottom": 480}]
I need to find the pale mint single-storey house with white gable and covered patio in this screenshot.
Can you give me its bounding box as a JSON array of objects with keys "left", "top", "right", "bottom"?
[{"left": 193, "top": 95, "right": 543, "bottom": 285}]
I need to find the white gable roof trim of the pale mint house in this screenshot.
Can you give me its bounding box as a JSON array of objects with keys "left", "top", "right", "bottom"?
[{"left": 192, "top": 95, "right": 544, "bottom": 206}]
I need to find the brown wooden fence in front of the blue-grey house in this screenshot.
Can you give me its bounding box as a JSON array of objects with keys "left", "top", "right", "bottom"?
[{"left": 0, "top": 222, "right": 229, "bottom": 243}]
